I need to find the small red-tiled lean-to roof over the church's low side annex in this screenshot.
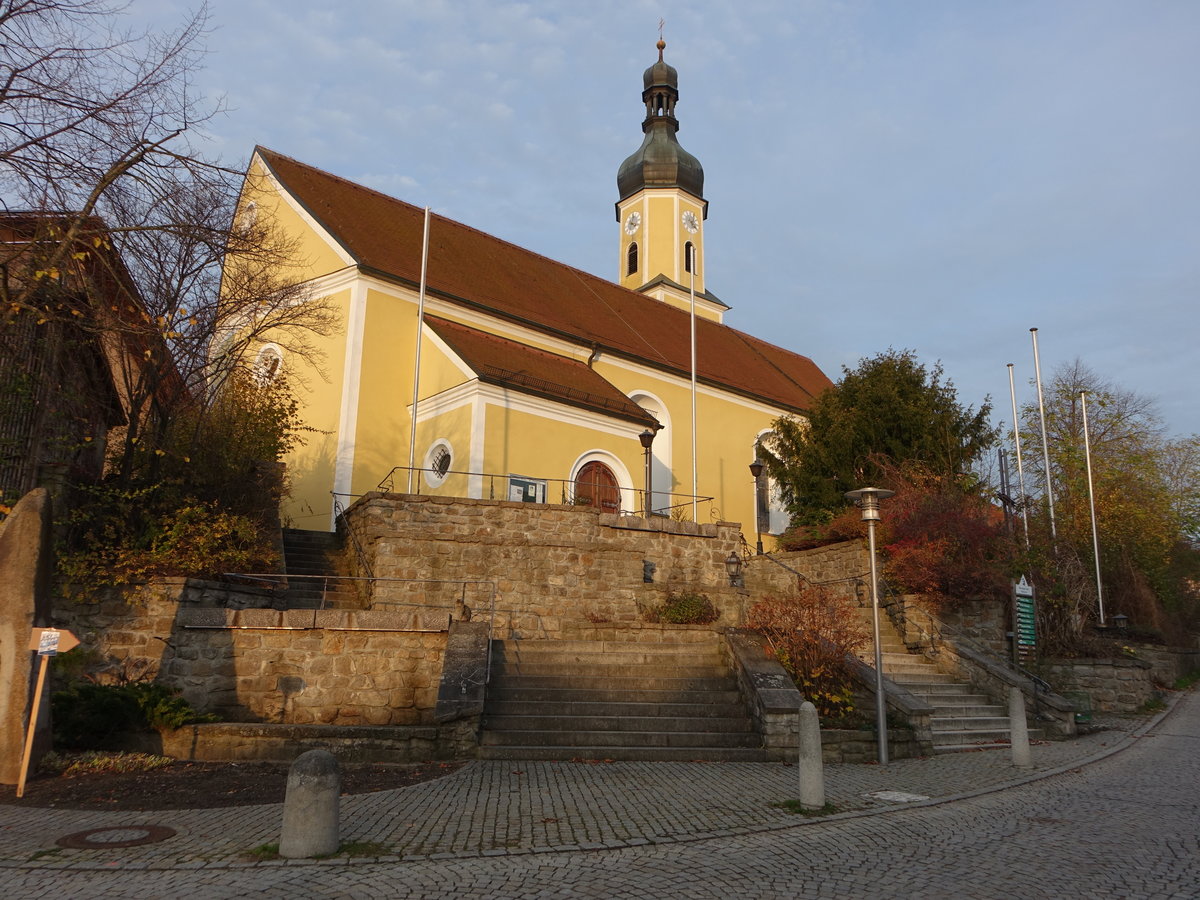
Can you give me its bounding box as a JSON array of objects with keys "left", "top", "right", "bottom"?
[{"left": 425, "top": 316, "right": 658, "bottom": 427}]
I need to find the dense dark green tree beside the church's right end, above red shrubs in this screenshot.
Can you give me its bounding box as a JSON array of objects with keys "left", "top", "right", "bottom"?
[{"left": 763, "top": 349, "right": 996, "bottom": 526}]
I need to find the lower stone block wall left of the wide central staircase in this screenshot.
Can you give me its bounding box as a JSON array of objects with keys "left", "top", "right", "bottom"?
[{"left": 54, "top": 578, "right": 449, "bottom": 725}]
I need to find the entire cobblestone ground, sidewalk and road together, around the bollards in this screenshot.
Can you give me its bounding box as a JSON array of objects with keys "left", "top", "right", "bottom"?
[{"left": 0, "top": 695, "right": 1200, "bottom": 898}]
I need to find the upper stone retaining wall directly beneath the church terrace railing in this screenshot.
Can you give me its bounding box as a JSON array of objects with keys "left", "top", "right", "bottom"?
[{"left": 347, "top": 493, "right": 745, "bottom": 638}]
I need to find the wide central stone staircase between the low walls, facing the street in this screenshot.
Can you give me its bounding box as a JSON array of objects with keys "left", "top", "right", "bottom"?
[{"left": 480, "top": 635, "right": 767, "bottom": 762}]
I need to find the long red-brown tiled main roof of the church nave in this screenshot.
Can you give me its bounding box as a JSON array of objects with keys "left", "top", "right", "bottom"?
[{"left": 257, "top": 148, "right": 830, "bottom": 410}]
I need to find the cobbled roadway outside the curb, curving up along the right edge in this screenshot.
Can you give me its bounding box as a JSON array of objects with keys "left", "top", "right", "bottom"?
[{"left": 0, "top": 695, "right": 1200, "bottom": 900}]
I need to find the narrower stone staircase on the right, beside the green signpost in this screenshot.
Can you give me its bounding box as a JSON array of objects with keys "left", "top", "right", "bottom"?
[{"left": 858, "top": 607, "right": 1038, "bottom": 752}]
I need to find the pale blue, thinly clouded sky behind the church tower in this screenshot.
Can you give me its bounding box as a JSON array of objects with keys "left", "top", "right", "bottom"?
[{"left": 128, "top": 0, "right": 1200, "bottom": 434}]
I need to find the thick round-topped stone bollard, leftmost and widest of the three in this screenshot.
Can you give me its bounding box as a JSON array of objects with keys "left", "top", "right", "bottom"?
[{"left": 280, "top": 750, "right": 342, "bottom": 859}]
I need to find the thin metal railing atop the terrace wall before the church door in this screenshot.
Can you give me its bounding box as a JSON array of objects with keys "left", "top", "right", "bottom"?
[{"left": 372, "top": 466, "right": 720, "bottom": 521}]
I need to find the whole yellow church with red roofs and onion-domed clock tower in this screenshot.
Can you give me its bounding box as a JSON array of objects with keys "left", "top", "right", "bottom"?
[{"left": 239, "top": 43, "right": 829, "bottom": 540}]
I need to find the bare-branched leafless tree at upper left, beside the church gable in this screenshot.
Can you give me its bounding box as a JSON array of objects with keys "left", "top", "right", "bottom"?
[{"left": 0, "top": 0, "right": 335, "bottom": 501}]
